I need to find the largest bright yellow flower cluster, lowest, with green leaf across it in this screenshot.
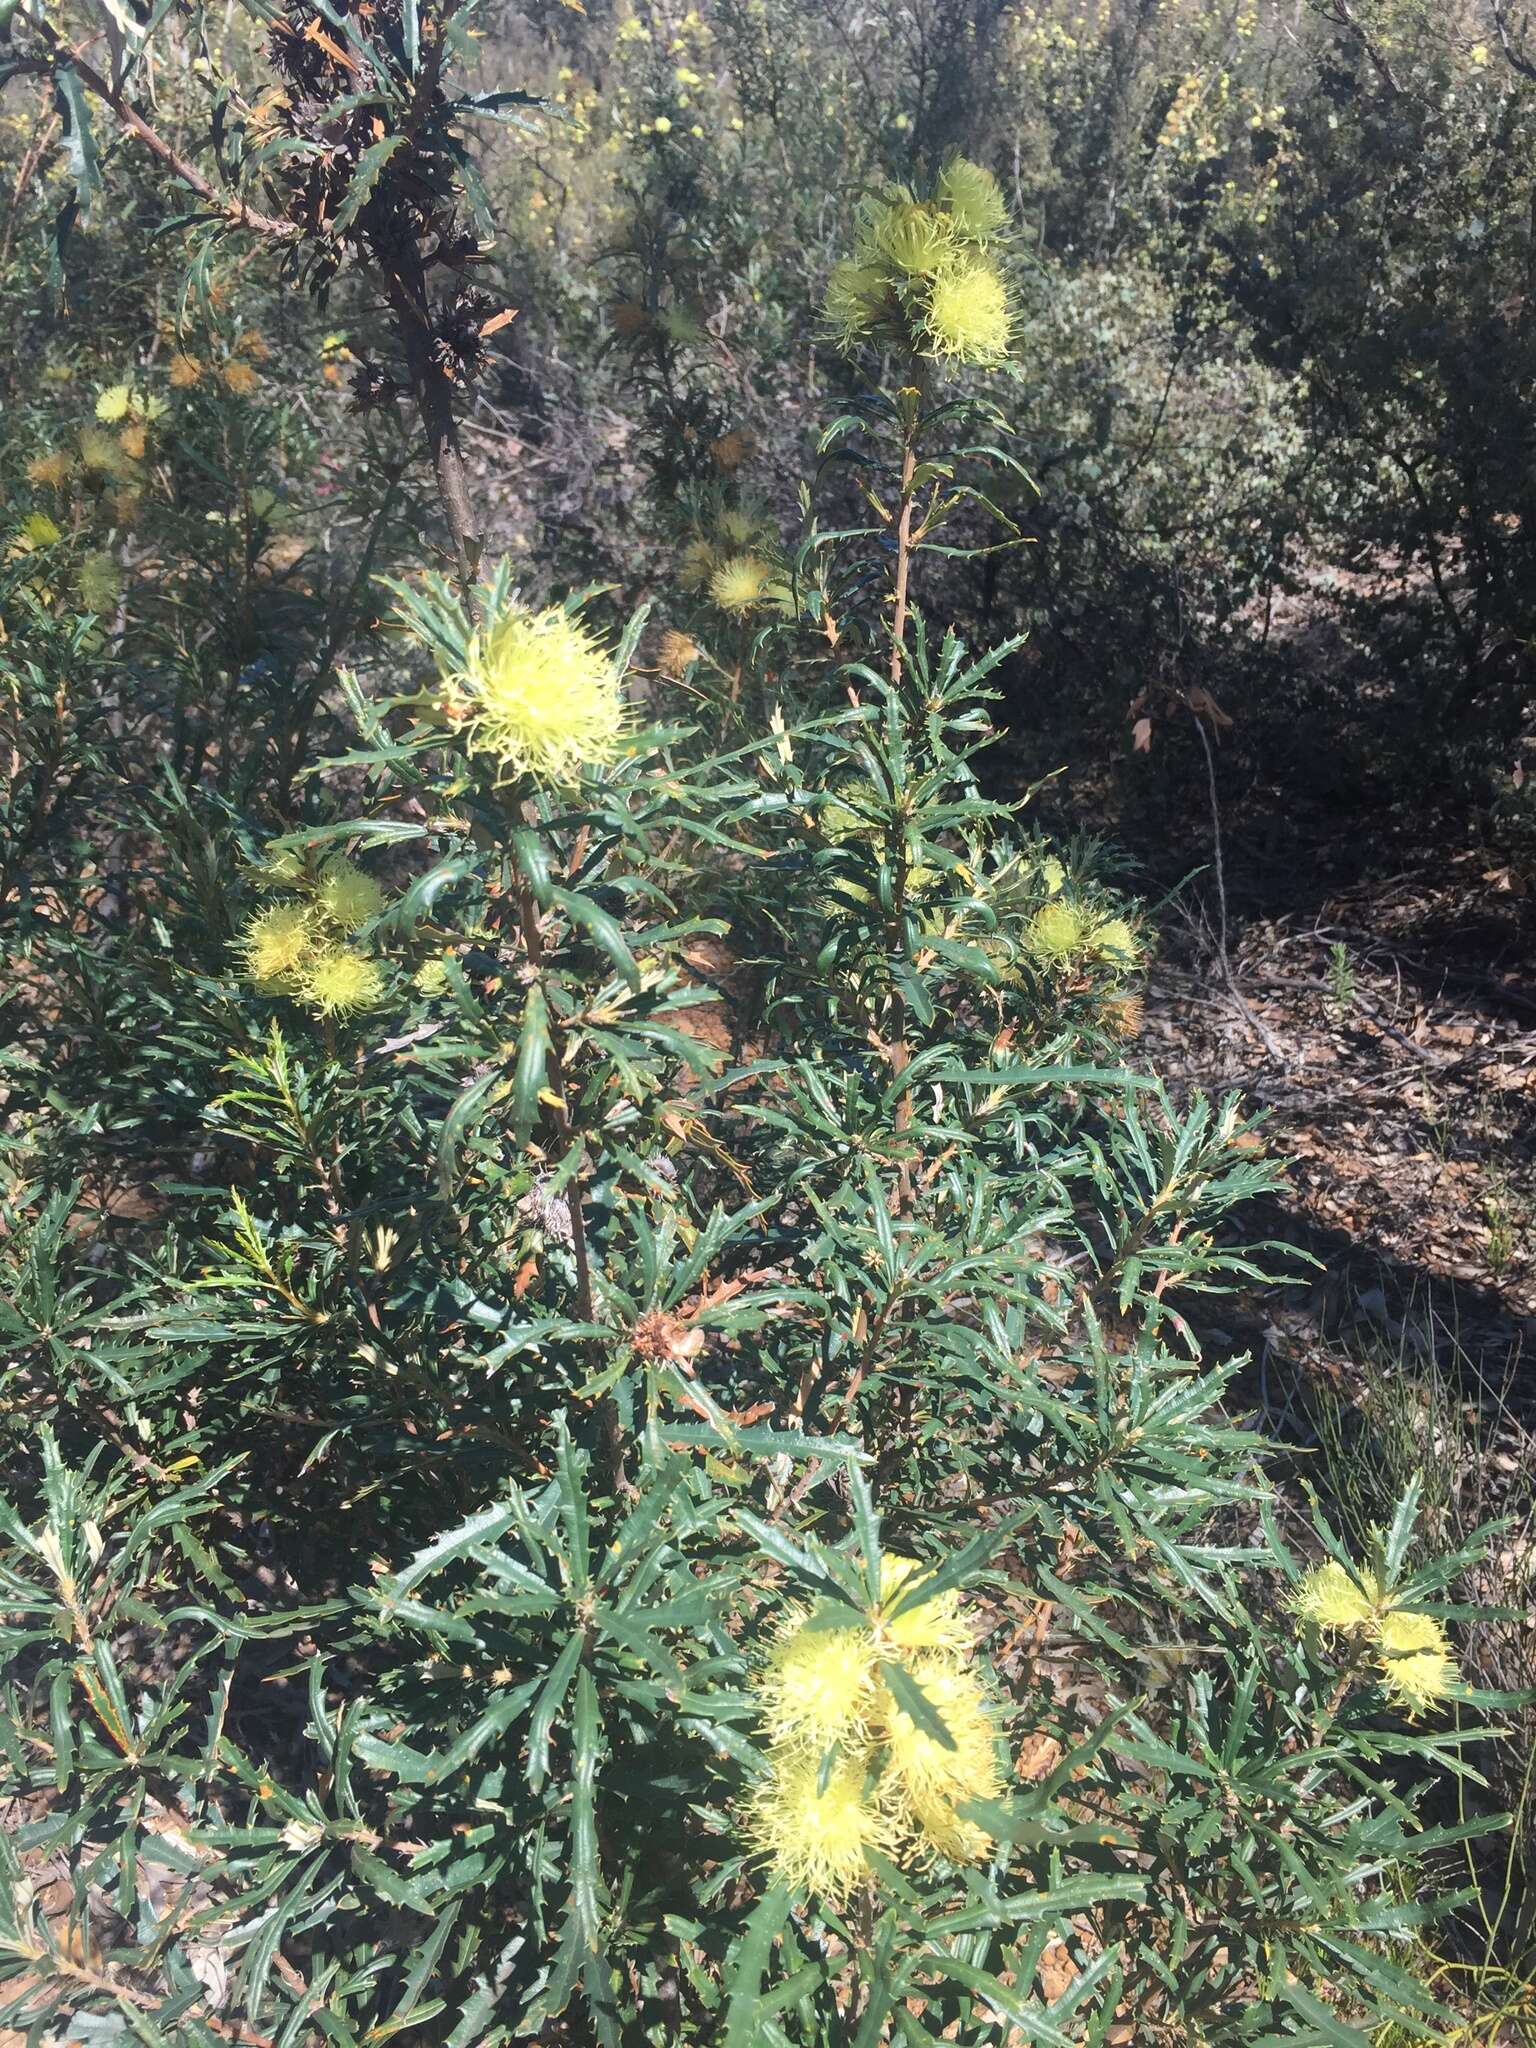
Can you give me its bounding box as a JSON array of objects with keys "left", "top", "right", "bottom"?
[{"left": 750, "top": 1556, "right": 1004, "bottom": 1901}]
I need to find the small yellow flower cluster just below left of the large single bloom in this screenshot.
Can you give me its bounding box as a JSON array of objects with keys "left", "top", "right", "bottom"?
[{"left": 238, "top": 850, "right": 385, "bottom": 1018}]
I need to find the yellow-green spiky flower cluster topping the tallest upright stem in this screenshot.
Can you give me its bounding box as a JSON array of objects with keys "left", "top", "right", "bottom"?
[{"left": 825, "top": 156, "right": 1014, "bottom": 365}]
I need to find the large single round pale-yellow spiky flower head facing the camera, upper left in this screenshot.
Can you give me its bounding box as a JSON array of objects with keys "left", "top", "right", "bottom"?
[{"left": 449, "top": 604, "right": 625, "bottom": 786}]
